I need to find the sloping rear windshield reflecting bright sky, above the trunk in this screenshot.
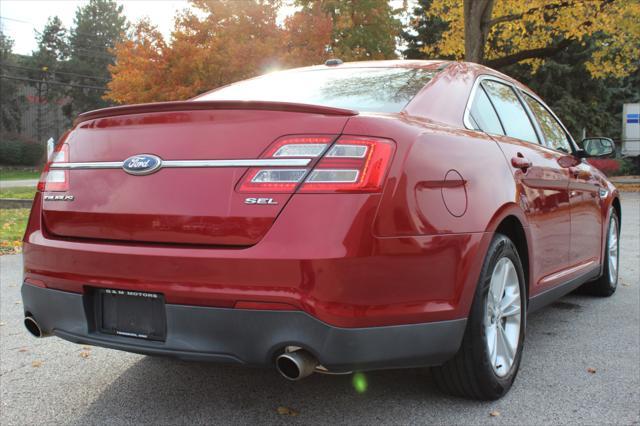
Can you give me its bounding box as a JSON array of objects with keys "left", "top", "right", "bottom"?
[{"left": 195, "top": 68, "right": 435, "bottom": 112}]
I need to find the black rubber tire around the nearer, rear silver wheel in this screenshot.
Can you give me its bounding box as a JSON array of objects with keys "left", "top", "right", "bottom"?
[{"left": 432, "top": 234, "right": 527, "bottom": 400}]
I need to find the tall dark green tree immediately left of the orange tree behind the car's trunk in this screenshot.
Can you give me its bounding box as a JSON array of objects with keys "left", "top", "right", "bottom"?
[{"left": 66, "top": 0, "right": 128, "bottom": 115}]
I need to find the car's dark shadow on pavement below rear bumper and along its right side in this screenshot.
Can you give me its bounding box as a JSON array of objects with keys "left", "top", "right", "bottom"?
[{"left": 70, "top": 294, "right": 592, "bottom": 424}]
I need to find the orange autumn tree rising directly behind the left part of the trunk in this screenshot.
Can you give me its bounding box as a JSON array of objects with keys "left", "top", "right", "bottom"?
[{"left": 106, "top": 0, "right": 284, "bottom": 103}]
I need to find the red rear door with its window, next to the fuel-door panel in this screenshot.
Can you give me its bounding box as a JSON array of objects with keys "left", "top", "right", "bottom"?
[{"left": 470, "top": 78, "right": 571, "bottom": 295}]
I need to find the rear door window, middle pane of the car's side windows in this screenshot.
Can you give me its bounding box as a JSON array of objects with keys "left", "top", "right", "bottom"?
[{"left": 482, "top": 80, "right": 538, "bottom": 143}]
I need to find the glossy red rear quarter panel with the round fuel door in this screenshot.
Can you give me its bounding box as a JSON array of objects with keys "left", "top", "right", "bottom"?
[{"left": 345, "top": 115, "right": 517, "bottom": 237}]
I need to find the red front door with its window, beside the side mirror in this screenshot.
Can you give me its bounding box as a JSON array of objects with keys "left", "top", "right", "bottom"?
[{"left": 524, "top": 93, "right": 603, "bottom": 266}]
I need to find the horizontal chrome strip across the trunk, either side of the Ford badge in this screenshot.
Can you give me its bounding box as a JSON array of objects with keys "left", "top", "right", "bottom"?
[{"left": 51, "top": 158, "right": 311, "bottom": 170}]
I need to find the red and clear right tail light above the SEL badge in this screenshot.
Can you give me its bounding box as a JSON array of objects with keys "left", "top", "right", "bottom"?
[{"left": 238, "top": 136, "right": 395, "bottom": 193}]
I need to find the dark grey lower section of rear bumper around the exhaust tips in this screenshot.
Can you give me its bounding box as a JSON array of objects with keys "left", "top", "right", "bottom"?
[{"left": 22, "top": 283, "right": 466, "bottom": 372}]
